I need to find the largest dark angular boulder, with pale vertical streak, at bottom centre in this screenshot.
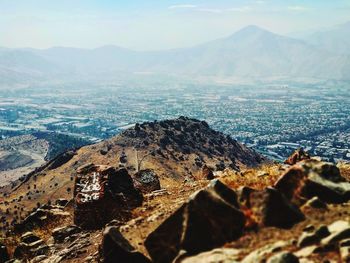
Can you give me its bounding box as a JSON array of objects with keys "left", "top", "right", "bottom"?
[{"left": 145, "top": 180, "right": 245, "bottom": 262}]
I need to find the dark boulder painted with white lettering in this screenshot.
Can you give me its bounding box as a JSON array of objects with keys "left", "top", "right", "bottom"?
[{"left": 74, "top": 164, "right": 143, "bottom": 229}]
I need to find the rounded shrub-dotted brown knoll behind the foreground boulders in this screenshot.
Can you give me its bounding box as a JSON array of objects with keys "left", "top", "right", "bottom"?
[{"left": 0, "top": 117, "right": 265, "bottom": 229}]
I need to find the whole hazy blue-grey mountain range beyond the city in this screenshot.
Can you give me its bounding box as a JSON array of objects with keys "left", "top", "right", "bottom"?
[{"left": 0, "top": 23, "right": 350, "bottom": 84}]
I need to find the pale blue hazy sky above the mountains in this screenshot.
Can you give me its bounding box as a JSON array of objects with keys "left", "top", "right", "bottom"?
[{"left": 0, "top": 0, "right": 350, "bottom": 50}]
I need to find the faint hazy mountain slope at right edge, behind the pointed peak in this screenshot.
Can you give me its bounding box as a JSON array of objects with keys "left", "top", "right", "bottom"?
[{"left": 304, "top": 22, "right": 350, "bottom": 55}]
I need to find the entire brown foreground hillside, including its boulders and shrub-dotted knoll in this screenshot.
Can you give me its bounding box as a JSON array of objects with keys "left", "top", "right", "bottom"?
[{"left": 0, "top": 117, "right": 350, "bottom": 263}]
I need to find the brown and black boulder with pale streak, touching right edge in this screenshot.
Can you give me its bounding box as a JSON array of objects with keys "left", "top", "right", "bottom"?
[{"left": 274, "top": 160, "right": 350, "bottom": 203}]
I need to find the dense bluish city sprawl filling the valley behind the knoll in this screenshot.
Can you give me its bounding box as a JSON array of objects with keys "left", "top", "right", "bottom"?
[{"left": 0, "top": 82, "right": 350, "bottom": 161}]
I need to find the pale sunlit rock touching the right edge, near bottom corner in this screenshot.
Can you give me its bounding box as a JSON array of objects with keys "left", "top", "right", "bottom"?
[{"left": 321, "top": 220, "right": 350, "bottom": 246}]
